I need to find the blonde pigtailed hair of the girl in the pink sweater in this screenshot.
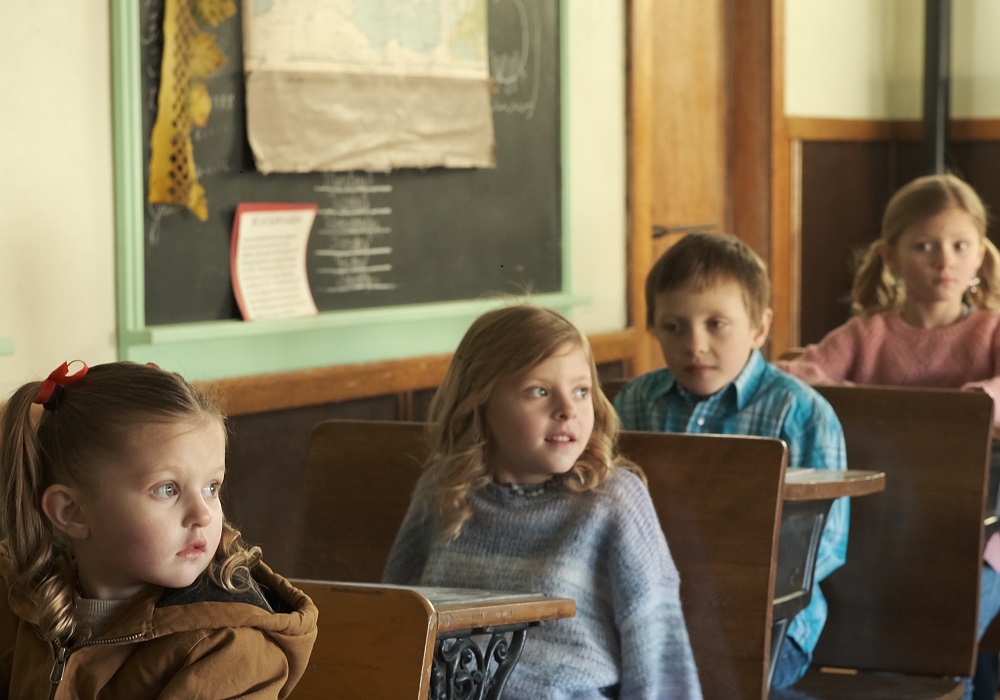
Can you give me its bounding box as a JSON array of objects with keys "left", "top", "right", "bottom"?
[{"left": 851, "top": 173, "right": 1000, "bottom": 316}]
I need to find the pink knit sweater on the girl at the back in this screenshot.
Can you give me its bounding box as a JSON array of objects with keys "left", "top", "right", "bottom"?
[{"left": 775, "top": 311, "right": 1000, "bottom": 425}]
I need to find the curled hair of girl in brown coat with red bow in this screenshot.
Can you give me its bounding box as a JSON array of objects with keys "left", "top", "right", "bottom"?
[{"left": 0, "top": 362, "right": 260, "bottom": 642}]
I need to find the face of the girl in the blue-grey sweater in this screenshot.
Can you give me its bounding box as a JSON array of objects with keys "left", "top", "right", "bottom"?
[{"left": 486, "top": 344, "right": 594, "bottom": 484}]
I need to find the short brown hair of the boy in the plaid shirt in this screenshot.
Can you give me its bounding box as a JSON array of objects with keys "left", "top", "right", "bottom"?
[{"left": 646, "top": 233, "right": 771, "bottom": 328}]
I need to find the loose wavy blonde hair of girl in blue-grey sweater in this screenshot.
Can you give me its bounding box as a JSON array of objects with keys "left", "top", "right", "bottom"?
[{"left": 425, "top": 305, "right": 641, "bottom": 539}]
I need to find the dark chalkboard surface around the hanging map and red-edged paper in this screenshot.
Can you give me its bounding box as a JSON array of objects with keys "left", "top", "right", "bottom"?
[{"left": 139, "top": 0, "right": 562, "bottom": 326}]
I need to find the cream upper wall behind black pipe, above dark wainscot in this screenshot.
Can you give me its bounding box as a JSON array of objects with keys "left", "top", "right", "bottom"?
[{"left": 785, "top": 0, "right": 1000, "bottom": 119}]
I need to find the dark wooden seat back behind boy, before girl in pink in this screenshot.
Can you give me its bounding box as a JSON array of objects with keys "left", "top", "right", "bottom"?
[{"left": 814, "top": 386, "right": 993, "bottom": 676}]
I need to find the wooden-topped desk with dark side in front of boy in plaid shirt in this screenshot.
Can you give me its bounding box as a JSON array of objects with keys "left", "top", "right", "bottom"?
[{"left": 770, "top": 468, "right": 885, "bottom": 675}]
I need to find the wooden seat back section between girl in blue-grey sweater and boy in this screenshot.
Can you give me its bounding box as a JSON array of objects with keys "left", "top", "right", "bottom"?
[{"left": 620, "top": 431, "right": 787, "bottom": 699}]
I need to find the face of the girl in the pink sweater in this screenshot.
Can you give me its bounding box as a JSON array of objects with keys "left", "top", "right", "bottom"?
[{"left": 883, "top": 208, "right": 986, "bottom": 313}]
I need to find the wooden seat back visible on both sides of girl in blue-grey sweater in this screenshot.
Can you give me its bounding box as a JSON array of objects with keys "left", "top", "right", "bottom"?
[{"left": 295, "top": 420, "right": 786, "bottom": 699}]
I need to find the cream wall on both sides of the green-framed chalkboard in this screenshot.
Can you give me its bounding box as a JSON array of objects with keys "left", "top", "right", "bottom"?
[{"left": 0, "top": 0, "right": 626, "bottom": 398}]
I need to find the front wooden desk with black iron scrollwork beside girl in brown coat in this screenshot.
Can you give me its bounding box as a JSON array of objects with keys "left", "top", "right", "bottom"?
[{"left": 292, "top": 579, "right": 576, "bottom": 700}]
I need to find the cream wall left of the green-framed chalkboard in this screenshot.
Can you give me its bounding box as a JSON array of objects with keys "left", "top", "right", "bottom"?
[{"left": 0, "top": 2, "right": 115, "bottom": 397}]
